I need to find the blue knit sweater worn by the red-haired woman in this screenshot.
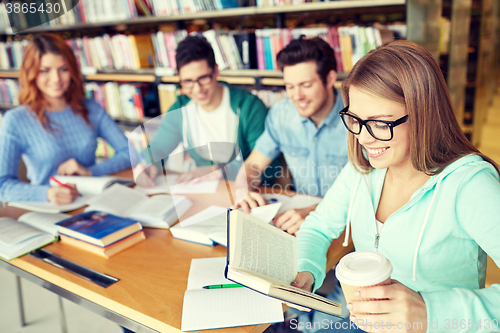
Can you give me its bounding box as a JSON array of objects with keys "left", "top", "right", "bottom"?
[{"left": 0, "top": 100, "right": 130, "bottom": 202}]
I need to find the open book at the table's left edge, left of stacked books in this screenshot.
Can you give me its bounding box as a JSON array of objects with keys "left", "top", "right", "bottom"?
[{"left": 0, "top": 212, "right": 70, "bottom": 260}]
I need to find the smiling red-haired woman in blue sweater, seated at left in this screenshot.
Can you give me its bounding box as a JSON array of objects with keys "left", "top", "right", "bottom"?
[{"left": 0, "top": 34, "right": 130, "bottom": 204}]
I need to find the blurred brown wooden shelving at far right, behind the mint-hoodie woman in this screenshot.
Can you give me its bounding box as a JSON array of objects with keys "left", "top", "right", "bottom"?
[{"left": 444, "top": 0, "right": 500, "bottom": 142}]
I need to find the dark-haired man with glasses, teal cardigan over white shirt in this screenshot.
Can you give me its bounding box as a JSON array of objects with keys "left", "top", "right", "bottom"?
[{"left": 137, "top": 35, "right": 267, "bottom": 183}]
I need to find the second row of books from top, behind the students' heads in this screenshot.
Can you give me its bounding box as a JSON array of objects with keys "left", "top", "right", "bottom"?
[{"left": 0, "top": 24, "right": 406, "bottom": 74}]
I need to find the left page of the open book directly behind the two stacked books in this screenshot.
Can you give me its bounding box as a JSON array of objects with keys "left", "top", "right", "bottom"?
[{"left": 85, "top": 184, "right": 148, "bottom": 216}]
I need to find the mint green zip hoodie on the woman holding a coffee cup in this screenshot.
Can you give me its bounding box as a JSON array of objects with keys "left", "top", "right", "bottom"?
[{"left": 297, "top": 155, "right": 500, "bottom": 332}]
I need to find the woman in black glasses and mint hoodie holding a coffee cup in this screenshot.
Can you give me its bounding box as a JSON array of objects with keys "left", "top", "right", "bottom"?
[{"left": 294, "top": 41, "right": 500, "bottom": 332}]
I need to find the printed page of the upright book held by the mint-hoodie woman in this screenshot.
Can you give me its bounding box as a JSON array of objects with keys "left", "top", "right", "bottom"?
[{"left": 230, "top": 211, "right": 297, "bottom": 285}]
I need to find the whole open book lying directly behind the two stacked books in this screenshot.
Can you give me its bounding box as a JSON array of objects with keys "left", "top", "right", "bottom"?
[{"left": 85, "top": 184, "right": 192, "bottom": 229}]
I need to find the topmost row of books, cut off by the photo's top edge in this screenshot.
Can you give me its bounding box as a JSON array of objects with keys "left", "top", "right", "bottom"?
[{"left": 0, "top": 0, "right": 328, "bottom": 31}]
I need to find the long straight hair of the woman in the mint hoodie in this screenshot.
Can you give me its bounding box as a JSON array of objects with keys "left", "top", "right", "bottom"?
[{"left": 342, "top": 40, "right": 499, "bottom": 175}]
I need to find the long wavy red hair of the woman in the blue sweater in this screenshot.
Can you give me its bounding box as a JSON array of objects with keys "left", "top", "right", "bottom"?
[{"left": 19, "top": 34, "right": 90, "bottom": 130}]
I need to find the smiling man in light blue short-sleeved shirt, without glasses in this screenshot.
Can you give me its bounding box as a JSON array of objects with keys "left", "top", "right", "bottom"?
[{"left": 237, "top": 38, "right": 347, "bottom": 234}]
